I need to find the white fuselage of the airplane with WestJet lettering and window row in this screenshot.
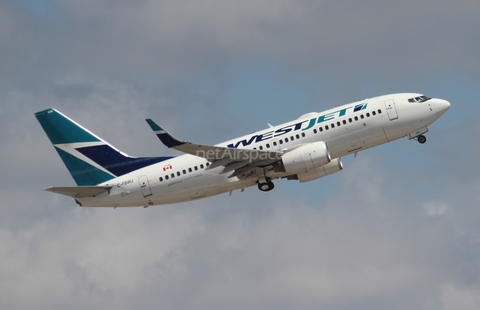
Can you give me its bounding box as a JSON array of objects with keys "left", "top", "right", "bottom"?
[{"left": 78, "top": 94, "right": 449, "bottom": 207}]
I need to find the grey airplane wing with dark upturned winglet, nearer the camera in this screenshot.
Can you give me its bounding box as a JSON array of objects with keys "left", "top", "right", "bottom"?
[{"left": 146, "top": 119, "right": 283, "bottom": 178}]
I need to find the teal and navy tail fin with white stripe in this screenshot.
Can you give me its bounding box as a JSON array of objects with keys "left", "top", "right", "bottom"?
[{"left": 35, "top": 109, "right": 172, "bottom": 186}]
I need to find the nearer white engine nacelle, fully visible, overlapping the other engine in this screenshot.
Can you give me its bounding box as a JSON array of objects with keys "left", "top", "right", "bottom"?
[{"left": 274, "top": 141, "right": 331, "bottom": 174}]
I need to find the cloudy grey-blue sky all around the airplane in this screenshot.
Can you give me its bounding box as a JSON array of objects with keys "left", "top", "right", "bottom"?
[{"left": 0, "top": 0, "right": 480, "bottom": 310}]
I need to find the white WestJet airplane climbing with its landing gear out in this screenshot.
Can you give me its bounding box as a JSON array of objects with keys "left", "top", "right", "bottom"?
[{"left": 35, "top": 93, "right": 450, "bottom": 208}]
